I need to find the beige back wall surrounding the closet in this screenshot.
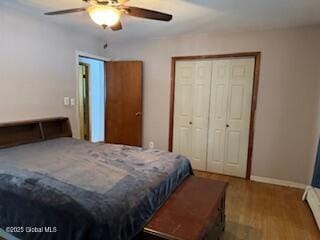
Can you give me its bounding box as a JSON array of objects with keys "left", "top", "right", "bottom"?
[{"left": 107, "top": 27, "right": 320, "bottom": 183}]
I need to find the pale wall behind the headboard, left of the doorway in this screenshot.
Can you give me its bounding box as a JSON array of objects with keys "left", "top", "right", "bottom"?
[{"left": 0, "top": 3, "right": 103, "bottom": 136}]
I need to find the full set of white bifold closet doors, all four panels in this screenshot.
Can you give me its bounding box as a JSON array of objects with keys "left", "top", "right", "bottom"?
[{"left": 173, "top": 58, "right": 255, "bottom": 177}]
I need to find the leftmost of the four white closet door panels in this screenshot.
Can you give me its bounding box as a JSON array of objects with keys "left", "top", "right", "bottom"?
[{"left": 172, "top": 61, "right": 195, "bottom": 159}]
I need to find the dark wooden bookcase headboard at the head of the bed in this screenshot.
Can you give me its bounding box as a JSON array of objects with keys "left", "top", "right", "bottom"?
[{"left": 0, "top": 117, "right": 72, "bottom": 148}]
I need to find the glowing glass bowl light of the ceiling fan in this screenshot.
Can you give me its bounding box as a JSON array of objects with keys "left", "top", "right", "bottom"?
[{"left": 88, "top": 6, "right": 121, "bottom": 27}]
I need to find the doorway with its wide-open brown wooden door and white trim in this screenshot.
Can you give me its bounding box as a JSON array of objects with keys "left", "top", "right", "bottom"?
[{"left": 75, "top": 51, "right": 143, "bottom": 146}]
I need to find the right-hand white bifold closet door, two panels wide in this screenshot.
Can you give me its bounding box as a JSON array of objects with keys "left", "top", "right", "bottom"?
[{"left": 207, "top": 58, "right": 255, "bottom": 177}]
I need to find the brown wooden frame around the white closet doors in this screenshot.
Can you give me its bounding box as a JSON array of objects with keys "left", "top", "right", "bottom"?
[{"left": 168, "top": 52, "right": 261, "bottom": 179}]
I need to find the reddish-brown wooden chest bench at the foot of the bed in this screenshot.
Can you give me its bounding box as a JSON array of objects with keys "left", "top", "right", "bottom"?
[{"left": 141, "top": 176, "right": 227, "bottom": 240}]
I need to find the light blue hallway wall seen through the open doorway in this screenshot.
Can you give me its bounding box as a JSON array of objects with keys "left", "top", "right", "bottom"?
[{"left": 79, "top": 57, "right": 105, "bottom": 142}]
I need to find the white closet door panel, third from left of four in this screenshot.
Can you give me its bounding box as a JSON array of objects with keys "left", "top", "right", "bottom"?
[{"left": 207, "top": 60, "right": 230, "bottom": 173}]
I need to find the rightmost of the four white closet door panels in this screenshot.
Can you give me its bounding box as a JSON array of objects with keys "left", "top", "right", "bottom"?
[{"left": 224, "top": 58, "right": 255, "bottom": 177}]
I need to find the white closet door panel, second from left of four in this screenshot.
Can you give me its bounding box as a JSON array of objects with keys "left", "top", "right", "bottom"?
[{"left": 191, "top": 61, "right": 212, "bottom": 171}]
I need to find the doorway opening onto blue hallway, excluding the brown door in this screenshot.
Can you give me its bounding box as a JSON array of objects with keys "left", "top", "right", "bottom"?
[{"left": 78, "top": 56, "right": 105, "bottom": 142}]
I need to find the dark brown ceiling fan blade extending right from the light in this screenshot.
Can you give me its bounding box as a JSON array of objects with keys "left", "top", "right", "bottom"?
[{"left": 124, "top": 6, "right": 172, "bottom": 21}]
